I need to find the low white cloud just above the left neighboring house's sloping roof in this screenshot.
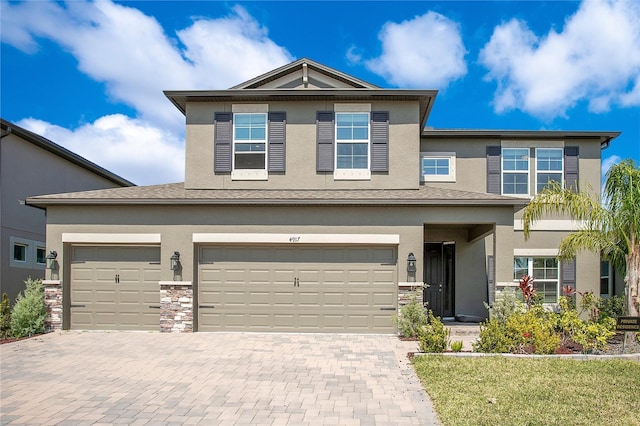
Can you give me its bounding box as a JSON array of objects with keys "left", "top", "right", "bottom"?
[{"left": 16, "top": 114, "right": 184, "bottom": 185}]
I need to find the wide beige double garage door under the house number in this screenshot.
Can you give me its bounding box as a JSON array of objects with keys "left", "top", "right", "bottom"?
[{"left": 198, "top": 246, "right": 397, "bottom": 333}]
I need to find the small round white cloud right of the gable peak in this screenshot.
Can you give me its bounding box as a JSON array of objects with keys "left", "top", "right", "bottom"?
[{"left": 365, "top": 12, "right": 467, "bottom": 89}]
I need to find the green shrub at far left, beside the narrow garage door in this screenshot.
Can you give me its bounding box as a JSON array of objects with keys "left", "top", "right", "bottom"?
[{"left": 11, "top": 278, "right": 47, "bottom": 337}]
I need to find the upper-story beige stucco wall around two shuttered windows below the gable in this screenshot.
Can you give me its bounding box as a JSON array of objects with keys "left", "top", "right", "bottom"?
[{"left": 185, "top": 101, "right": 420, "bottom": 189}]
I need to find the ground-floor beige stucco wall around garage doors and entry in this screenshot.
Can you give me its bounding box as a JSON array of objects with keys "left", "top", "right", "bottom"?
[{"left": 47, "top": 202, "right": 513, "bottom": 315}]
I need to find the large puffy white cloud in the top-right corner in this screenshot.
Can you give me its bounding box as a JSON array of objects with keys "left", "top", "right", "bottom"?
[{"left": 479, "top": 0, "right": 640, "bottom": 118}]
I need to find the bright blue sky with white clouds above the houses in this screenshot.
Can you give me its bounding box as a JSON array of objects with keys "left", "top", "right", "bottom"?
[{"left": 0, "top": 0, "right": 640, "bottom": 184}]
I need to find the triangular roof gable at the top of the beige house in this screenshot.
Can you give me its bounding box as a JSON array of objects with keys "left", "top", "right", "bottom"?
[{"left": 230, "top": 58, "right": 378, "bottom": 90}]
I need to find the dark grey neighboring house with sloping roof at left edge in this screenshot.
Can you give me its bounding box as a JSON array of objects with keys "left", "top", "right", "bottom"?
[{"left": 0, "top": 119, "right": 133, "bottom": 302}]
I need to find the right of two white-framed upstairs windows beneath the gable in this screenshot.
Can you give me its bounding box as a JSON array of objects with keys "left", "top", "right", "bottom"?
[{"left": 336, "top": 112, "right": 369, "bottom": 170}]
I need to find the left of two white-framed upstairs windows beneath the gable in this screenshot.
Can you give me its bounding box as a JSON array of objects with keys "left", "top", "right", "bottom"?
[{"left": 233, "top": 113, "right": 267, "bottom": 170}]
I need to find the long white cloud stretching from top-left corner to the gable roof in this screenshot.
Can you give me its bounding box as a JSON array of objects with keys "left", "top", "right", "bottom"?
[{"left": 2, "top": 0, "right": 292, "bottom": 130}]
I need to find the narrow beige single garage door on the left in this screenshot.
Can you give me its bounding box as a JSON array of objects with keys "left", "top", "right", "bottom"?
[{"left": 70, "top": 246, "right": 160, "bottom": 330}]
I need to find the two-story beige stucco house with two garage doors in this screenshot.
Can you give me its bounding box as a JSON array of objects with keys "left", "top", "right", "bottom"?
[{"left": 28, "top": 59, "right": 619, "bottom": 333}]
